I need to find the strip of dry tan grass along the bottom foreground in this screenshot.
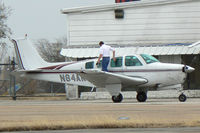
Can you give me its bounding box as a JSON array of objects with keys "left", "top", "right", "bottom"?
[{"left": 0, "top": 115, "right": 200, "bottom": 131}]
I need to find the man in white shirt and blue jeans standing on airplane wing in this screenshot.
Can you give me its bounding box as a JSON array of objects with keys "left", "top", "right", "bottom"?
[{"left": 97, "top": 41, "right": 116, "bottom": 72}]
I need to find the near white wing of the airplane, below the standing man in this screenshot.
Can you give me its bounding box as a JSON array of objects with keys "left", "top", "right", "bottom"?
[{"left": 80, "top": 70, "right": 148, "bottom": 88}]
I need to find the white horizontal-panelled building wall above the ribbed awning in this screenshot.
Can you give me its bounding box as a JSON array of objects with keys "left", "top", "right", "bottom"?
[{"left": 68, "top": 0, "right": 200, "bottom": 45}]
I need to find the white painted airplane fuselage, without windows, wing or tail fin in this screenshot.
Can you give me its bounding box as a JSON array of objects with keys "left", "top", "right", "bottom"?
[{"left": 26, "top": 55, "right": 186, "bottom": 88}]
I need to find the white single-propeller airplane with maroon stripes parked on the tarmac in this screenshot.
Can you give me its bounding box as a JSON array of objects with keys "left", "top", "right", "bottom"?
[{"left": 12, "top": 37, "right": 194, "bottom": 103}]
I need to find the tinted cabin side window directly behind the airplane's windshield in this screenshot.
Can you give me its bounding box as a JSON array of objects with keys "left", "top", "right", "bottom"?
[{"left": 125, "top": 56, "right": 142, "bottom": 66}]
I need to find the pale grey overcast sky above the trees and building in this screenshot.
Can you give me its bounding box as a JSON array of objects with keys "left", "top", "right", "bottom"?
[{"left": 0, "top": 0, "right": 115, "bottom": 41}]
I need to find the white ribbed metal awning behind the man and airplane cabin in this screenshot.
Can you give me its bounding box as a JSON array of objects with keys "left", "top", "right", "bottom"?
[{"left": 61, "top": 46, "right": 200, "bottom": 58}]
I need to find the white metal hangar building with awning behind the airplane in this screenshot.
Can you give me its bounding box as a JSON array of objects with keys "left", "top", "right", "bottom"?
[{"left": 61, "top": 0, "right": 200, "bottom": 95}]
